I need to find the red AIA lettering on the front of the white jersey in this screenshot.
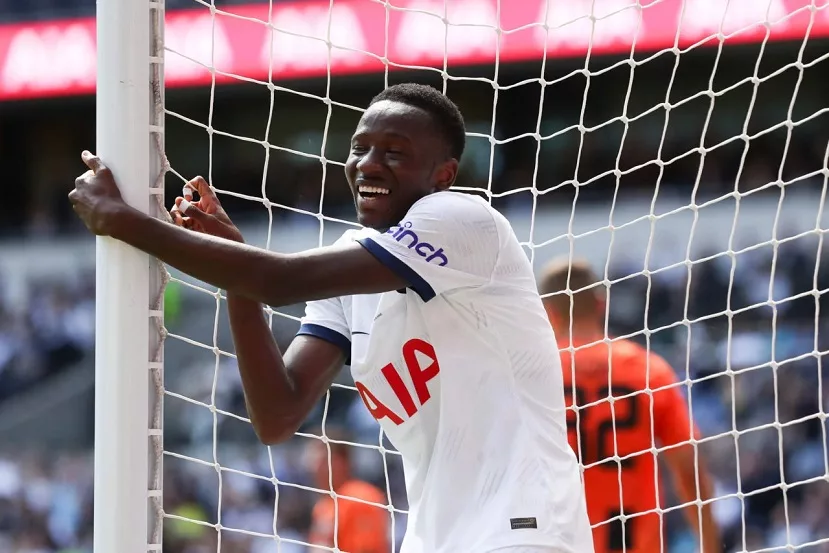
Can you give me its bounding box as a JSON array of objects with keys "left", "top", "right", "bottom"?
[{"left": 354, "top": 338, "right": 440, "bottom": 425}]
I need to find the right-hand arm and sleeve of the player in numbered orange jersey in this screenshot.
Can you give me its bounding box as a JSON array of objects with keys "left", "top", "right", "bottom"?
[{"left": 650, "top": 356, "right": 722, "bottom": 553}]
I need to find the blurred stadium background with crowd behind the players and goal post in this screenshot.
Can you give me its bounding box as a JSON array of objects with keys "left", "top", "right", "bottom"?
[{"left": 0, "top": 0, "right": 829, "bottom": 553}]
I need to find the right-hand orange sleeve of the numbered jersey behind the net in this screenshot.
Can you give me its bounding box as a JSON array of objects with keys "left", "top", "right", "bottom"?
[{"left": 650, "top": 355, "right": 697, "bottom": 446}]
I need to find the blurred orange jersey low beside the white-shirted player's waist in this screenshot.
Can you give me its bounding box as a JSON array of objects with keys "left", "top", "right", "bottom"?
[{"left": 309, "top": 480, "right": 391, "bottom": 553}]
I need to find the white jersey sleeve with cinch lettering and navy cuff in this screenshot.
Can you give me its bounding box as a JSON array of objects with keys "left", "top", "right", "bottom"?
[{"left": 357, "top": 192, "right": 500, "bottom": 302}]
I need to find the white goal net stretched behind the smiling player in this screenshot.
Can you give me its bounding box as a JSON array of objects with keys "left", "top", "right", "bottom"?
[{"left": 99, "top": 0, "right": 829, "bottom": 553}]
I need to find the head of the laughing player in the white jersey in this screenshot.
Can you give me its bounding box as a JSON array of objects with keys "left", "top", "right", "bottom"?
[{"left": 345, "top": 83, "right": 466, "bottom": 229}]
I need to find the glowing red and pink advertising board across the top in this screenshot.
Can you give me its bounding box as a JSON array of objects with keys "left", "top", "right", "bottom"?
[{"left": 0, "top": 0, "right": 829, "bottom": 100}]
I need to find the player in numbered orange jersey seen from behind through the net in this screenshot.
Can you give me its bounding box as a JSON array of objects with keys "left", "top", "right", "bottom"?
[{"left": 539, "top": 259, "right": 721, "bottom": 553}]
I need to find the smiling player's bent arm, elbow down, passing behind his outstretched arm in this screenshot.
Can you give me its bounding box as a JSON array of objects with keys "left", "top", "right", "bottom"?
[{"left": 170, "top": 179, "right": 347, "bottom": 444}]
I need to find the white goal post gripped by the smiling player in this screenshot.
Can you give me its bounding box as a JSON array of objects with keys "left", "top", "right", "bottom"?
[{"left": 93, "top": 0, "right": 164, "bottom": 553}]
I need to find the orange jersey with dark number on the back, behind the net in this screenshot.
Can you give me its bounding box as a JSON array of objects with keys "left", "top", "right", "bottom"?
[{"left": 559, "top": 340, "right": 695, "bottom": 553}]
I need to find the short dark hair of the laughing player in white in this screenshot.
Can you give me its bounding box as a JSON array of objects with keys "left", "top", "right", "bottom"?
[{"left": 369, "top": 83, "right": 466, "bottom": 161}]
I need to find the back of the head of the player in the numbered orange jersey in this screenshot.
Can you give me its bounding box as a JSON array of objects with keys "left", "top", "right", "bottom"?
[{"left": 538, "top": 256, "right": 605, "bottom": 335}]
